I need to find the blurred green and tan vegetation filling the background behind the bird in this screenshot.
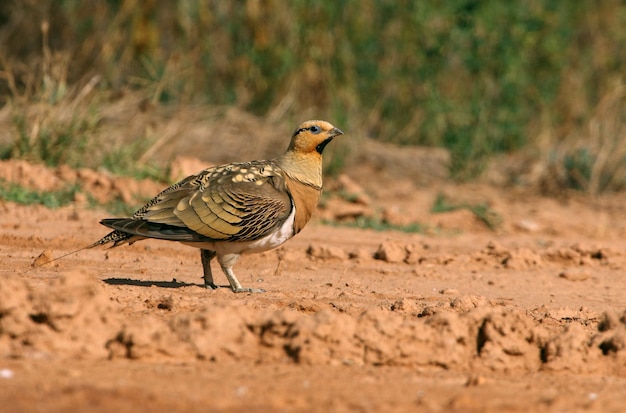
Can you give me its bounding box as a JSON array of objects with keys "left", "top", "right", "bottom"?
[{"left": 0, "top": 0, "right": 626, "bottom": 187}]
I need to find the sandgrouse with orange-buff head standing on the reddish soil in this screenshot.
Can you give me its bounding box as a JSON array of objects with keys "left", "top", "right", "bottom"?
[{"left": 86, "top": 120, "right": 344, "bottom": 293}]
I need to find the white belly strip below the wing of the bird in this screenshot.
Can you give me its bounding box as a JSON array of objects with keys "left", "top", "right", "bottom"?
[{"left": 183, "top": 204, "right": 296, "bottom": 255}]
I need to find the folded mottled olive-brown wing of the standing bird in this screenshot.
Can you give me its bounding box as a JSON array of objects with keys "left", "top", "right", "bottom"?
[{"left": 102, "top": 162, "right": 292, "bottom": 242}]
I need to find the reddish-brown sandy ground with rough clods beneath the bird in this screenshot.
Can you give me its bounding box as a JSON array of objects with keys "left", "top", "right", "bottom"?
[{"left": 0, "top": 157, "right": 626, "bottom": 412}]
